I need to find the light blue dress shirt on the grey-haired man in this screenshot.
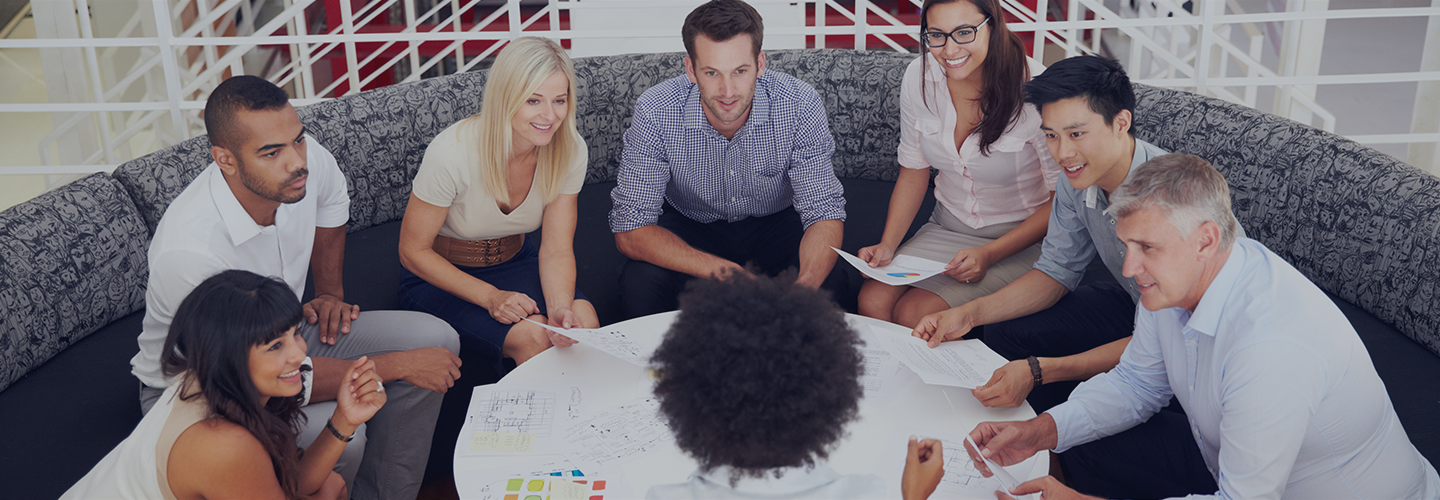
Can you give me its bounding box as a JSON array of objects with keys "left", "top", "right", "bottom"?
[{"left": 1048, "top": 238, "right": 1440, "bottom": 499}]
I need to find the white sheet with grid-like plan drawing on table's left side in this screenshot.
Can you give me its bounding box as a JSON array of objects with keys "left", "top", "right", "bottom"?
[{"left": 459, "top": 383, "right": 583, "bottom": 455}]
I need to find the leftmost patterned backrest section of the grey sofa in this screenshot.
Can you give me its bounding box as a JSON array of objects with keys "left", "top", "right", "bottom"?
[{"left": 0, "top": 173, "right": 150, "bottom": 398}]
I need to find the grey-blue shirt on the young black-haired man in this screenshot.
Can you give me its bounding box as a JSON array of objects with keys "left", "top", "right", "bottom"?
[{"left": 1035, "top": 138, "right": 1166, "bottom": 304}]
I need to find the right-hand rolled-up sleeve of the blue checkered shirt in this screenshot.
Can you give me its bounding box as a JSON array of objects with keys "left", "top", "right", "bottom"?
[{"left": 789, "top": 92, "right": 845, "bottom": 228}]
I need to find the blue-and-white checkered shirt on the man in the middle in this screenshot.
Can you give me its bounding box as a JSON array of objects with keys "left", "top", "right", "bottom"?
[{"left": 611, "top": 71, "right": 845, "bottom": 232}]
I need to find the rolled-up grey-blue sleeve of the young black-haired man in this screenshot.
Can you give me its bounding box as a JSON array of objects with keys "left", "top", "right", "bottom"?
[{"left": 1035, "top": 187, "right": 1096, "bottom": 290}]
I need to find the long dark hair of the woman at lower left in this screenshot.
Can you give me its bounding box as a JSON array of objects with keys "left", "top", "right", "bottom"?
[{"left": 160, "top": 269, "right": 310, "bottom": 499}]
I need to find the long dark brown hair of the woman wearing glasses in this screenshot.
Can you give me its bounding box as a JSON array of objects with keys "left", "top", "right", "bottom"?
[{"left": 920, "top": 0, "right": 1030, "bottom": 156}]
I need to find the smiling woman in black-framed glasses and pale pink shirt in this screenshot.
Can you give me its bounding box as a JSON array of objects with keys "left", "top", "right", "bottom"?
[{"left": 860, "top": 0, "right": 1060, "bottom": 327}]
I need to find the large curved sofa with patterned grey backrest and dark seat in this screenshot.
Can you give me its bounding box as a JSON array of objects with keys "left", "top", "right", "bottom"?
[{"left": 0, "top": 49, "right": 1440, "bottom": 499}]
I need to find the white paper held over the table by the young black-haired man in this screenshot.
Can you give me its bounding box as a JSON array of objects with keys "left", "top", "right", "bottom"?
[{"left": 870, "top": 326, "right": 1007, "bottom": 389}]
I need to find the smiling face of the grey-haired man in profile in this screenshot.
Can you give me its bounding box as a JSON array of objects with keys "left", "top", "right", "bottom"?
[{"left": 1115, "top": 206, "right": 1220, "bottom": 311}]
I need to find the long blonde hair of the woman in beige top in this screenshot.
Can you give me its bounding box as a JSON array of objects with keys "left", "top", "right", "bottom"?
[{"left": 465, "top": 36, "right": 585, "bottom": 206}]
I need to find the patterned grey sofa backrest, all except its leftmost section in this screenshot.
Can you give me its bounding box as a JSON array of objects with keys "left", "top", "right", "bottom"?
[{"left": 98, "top": 49, "right": 1440, "bottom": 353}]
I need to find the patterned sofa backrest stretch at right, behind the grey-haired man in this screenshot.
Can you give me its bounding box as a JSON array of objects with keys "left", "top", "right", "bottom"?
[{"left": 1135, "top": 85, "right": 1440, "bottom": 353}]
